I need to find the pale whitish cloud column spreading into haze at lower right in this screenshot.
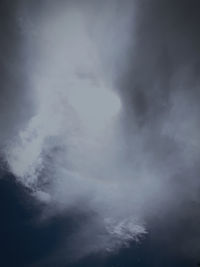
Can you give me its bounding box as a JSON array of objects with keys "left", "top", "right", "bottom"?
[{"left": 4, "top": 1, "right": 199, "bottom": 256}]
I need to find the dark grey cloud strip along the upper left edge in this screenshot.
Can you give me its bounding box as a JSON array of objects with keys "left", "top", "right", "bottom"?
[{"left": 0, "top": 1, "right": 35, "bottom": 151}]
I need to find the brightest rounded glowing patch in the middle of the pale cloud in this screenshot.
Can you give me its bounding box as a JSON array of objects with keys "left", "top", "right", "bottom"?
[{"left": 69, "top": 86, "right": 121, "bottom": 133}]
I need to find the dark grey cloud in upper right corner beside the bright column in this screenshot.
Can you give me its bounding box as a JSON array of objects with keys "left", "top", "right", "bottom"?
[{"left": 120, "top": 0, "right": 200, "bottom": 120}]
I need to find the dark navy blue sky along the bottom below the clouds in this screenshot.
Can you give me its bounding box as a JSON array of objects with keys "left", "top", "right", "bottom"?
[{"left": 0, "top": 175, "right": 197, "bottom": 267}]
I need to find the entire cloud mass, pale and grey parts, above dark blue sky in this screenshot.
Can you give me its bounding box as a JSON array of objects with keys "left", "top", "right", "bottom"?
[{"left": 0, "top": 1, "right": 199, "bottom": 264}]
